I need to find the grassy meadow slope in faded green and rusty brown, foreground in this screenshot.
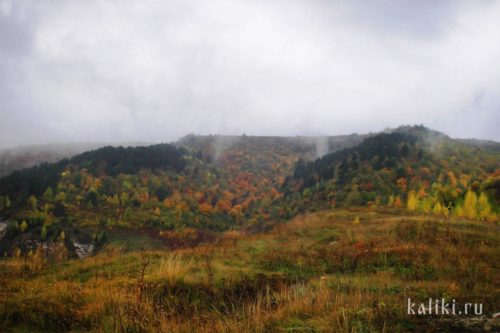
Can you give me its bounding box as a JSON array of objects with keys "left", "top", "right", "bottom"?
[{"left": 0, "top": 208, "right": 500, "bottom": 332}]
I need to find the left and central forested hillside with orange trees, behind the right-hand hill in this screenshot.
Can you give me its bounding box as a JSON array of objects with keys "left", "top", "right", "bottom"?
[{"left": 0, "top": 135, "right": 363, "bottom": 253}]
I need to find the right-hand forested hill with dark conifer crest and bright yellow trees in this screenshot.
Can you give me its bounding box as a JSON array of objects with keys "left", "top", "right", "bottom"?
[{"left": 284, "top": 126, "right": 500, "bottom": 219}]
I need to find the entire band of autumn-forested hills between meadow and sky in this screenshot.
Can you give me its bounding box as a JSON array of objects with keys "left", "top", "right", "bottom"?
[{"left": 0, "top": 126, "right": 500, "bottom": 253}]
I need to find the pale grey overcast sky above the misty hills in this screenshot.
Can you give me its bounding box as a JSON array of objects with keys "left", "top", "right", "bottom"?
[{"left": 0, "top": 0, "right": 500, "bottom": 147}]
